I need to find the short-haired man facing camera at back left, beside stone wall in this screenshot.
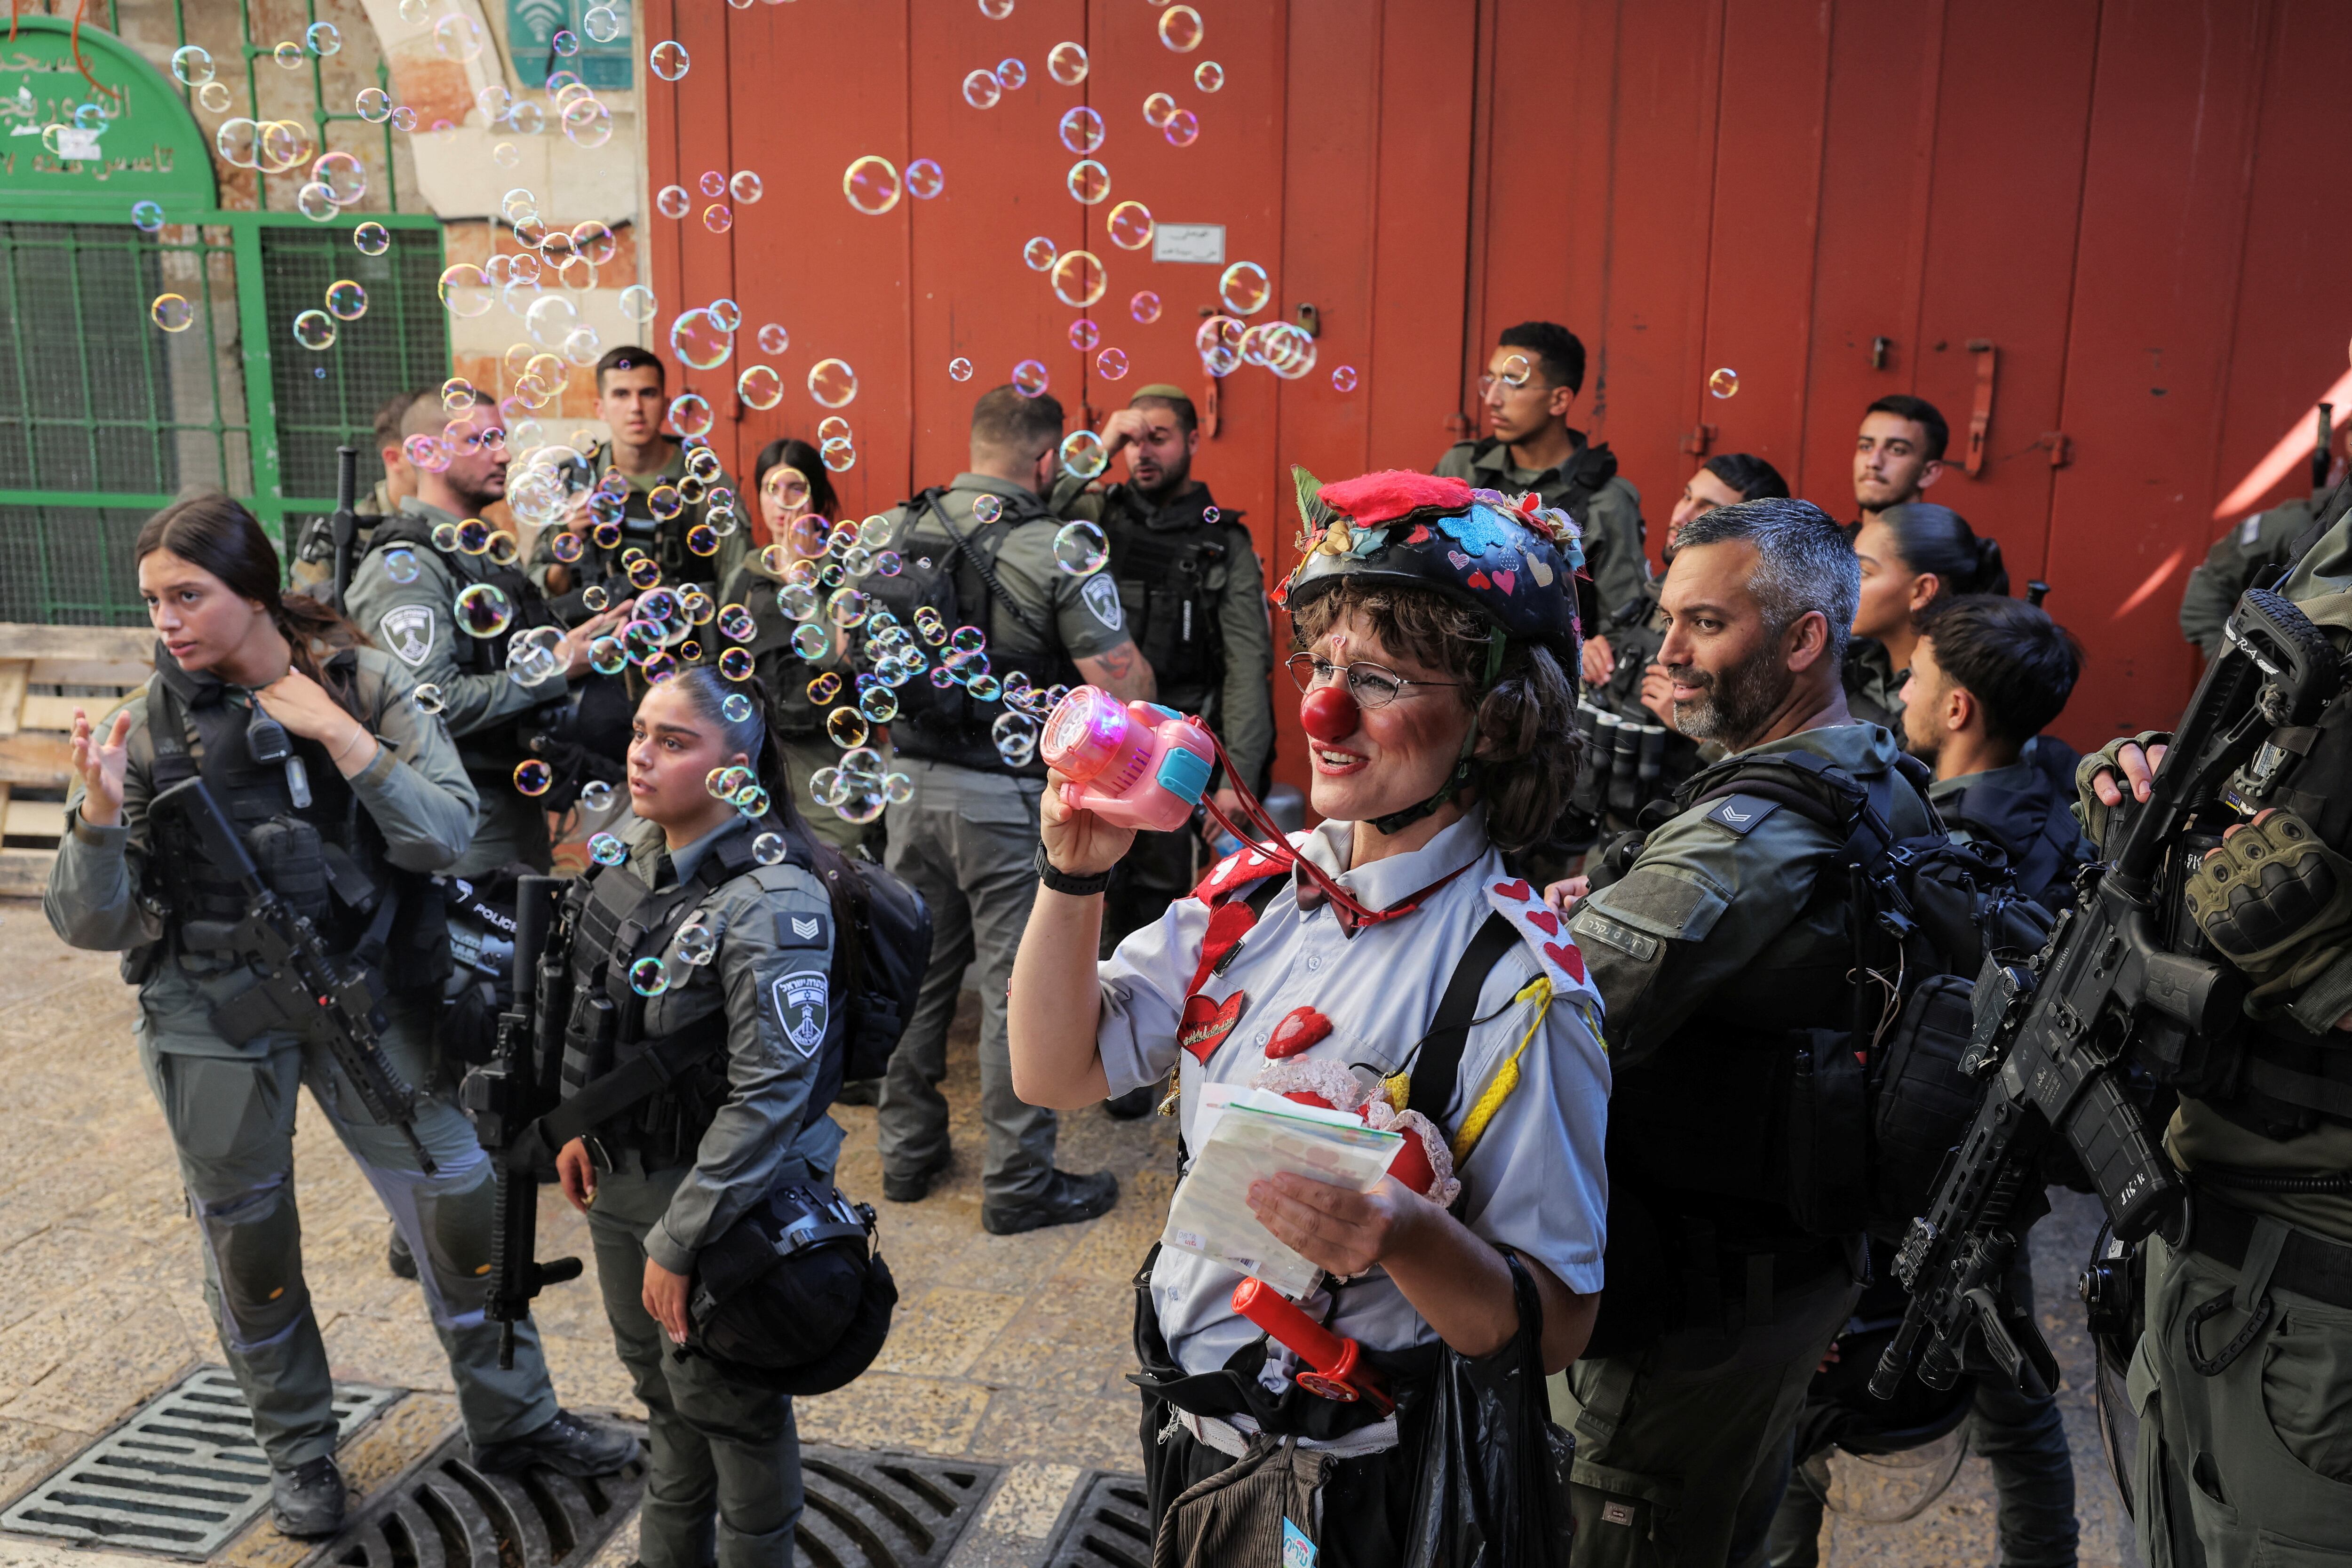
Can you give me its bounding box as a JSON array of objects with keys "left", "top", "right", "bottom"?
[{"left": 532, "top": 348, "right": 750, "bottom": 616}]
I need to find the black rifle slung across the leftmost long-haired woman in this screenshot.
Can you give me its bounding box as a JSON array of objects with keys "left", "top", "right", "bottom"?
[{"left": 148, "top": 778, "right": 435, "bottom": 1176}]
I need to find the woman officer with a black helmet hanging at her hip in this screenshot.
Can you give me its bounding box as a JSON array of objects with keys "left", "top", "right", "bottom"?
[{"left": 555, "top": 665, "right": 847, "bottom": 1568}]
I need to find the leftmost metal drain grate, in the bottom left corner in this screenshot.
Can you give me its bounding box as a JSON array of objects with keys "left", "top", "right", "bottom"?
[{"left": 0, "top": 1366, "right": 400, "bottom": 1556}]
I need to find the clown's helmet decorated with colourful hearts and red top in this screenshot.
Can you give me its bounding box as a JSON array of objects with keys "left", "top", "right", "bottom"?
[{"left": 1275, "top": 468, "right": 1585, "bottom": 670}]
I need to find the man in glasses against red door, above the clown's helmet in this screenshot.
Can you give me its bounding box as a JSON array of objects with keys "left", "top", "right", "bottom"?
[{"left": 1432, "top": 322, "right": 1649, "bottom": 628}]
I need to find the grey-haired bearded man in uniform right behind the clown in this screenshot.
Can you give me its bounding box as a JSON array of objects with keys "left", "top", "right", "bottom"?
[{"left": 1566, "top": 501, "right": 1929, "bottom": 1568}]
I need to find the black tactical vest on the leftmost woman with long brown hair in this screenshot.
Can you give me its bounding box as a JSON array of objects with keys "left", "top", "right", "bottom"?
[{"left": 141, "top": 644, "right": 449, "bottom": 992}]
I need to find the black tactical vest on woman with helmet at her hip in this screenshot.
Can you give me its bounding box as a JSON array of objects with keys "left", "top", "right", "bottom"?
[{"left": 550, "top": 825, "right": 847, "bottom": 1169}]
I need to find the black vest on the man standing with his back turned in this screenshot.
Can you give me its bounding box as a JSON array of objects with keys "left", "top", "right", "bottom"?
[{"left": 866, "top": 486, "right": 1082, "bottom": 778}]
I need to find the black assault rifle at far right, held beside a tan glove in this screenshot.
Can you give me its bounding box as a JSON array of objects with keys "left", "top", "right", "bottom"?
[{"left": 1870, "top": 588, "right": 2343, "bottom": 1399}]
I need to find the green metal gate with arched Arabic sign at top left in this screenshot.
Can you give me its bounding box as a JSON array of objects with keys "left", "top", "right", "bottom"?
[{"left": 0, "top": 16, "right": 449, "bottom": 625}]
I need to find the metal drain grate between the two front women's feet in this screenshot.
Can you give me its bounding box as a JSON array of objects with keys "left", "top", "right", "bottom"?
[{"left": 318, "top": 1434, "right": 644, "bottom": 1568}]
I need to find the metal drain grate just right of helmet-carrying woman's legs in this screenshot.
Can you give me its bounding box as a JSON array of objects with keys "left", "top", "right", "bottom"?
[{"left": 795, "top": 1448, "right": 1002, "bottom": 1568}]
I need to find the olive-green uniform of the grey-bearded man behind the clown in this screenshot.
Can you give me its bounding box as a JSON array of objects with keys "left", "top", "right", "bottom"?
[{"left": 1555, "top": 724, "right": 1929, "bottom": 1568}]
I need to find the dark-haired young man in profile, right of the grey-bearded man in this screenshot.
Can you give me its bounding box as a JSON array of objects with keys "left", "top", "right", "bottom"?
[{"left": 1903, "top": 592, "right": 2091, "bottom": 912}]
